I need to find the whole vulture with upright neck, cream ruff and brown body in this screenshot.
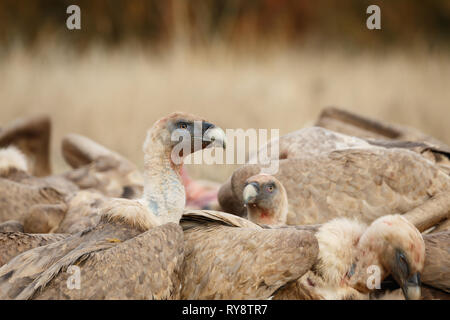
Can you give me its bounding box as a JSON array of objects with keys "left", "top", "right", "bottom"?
[{"left": 0, "top": 113, "right": 225, "bottom": 299}]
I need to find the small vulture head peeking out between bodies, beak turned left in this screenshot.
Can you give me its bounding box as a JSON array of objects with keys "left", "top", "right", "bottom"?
[{"left": 242, "top": 174, "right": 288, "bottom": 225}]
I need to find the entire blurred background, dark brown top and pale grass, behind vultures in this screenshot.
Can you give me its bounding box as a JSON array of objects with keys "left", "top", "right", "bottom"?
[{"left": 0, "top": 0, "right": 450, "bottom": 182}]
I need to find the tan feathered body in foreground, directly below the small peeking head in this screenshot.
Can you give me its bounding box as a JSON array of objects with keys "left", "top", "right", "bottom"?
[{"left": 181, "top": 210, "right": 318, "bottom": 299}]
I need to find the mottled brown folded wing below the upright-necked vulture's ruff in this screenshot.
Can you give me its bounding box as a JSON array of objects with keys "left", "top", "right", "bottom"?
[{"left": 35, "top": 223, "right": 184, "bottom": 299}]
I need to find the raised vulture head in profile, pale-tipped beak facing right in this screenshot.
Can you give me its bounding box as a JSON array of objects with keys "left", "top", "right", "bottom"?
[{"left": 144, "top": 112, "right": 226, "bottom": 166}]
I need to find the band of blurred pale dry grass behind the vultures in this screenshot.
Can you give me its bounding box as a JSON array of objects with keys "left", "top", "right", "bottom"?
[{"left": 0, "top": 46, "right": 450, "bottom": 181}]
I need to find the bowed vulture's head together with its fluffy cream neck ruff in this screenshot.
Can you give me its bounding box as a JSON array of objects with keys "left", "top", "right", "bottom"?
[{"left": 274, "top": 215, "right": 425, "bottom": 300}]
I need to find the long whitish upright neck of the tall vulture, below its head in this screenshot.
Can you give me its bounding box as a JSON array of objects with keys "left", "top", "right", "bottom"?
[{"left": 143, "top": 134, "right": 186, "bottom": 224}]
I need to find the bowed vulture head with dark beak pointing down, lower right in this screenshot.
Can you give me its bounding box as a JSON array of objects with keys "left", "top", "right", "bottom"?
[{"left": 360, "top": 215, "right": 425, "bottom": 299}]
